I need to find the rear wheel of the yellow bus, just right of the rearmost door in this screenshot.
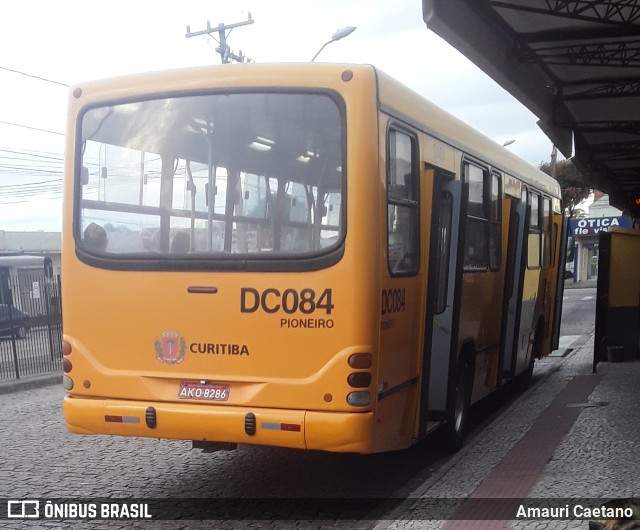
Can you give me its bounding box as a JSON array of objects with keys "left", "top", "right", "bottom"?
[{"left": 446, "top": 342, "right": 475, "bottom": 452}]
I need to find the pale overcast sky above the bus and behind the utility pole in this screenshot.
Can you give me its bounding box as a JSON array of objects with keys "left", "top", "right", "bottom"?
[{"left": 0, "top": 0, "right": 552, "bottom": 231}]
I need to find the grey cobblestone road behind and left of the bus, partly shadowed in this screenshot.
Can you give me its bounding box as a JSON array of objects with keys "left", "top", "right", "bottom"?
[{"left": 0, "top": 385, "right": 444, "bottom": 530}]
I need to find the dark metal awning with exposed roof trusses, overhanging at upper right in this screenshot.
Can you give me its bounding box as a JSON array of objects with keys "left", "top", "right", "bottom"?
[{"left": 423, "top": 0, "right": 640, "bottom": 215}]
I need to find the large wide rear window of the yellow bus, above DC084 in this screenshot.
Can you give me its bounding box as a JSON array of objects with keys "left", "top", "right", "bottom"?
[{"left": 76, "top": 93, "right": 346, "bottom": 261}]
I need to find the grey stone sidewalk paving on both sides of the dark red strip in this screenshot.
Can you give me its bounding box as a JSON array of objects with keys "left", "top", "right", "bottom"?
[{"left": 376, "top": 335, "right": 640, "bottom": 530}]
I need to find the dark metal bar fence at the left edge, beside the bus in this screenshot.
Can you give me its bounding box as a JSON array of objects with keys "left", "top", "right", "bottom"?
[{"left": 0, "top": 273, "right": 62, "bottom": 380}]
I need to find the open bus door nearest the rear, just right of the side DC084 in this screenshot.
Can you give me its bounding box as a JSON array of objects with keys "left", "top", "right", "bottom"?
[{"left": 419, "top": 168, "right": 463, "bottom": 437}]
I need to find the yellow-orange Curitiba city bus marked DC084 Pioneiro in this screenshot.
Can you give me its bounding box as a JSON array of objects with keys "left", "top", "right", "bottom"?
[{"left": 62, "top": 64, "right": 563, "bottom": 453}]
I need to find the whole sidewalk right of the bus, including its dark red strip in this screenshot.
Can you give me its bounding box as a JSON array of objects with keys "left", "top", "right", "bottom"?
[{"left": 376, "top": 334, "right": 640, "bottom": 530}]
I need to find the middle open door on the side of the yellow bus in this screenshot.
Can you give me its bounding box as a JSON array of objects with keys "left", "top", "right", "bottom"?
[{"left": 499, "top": 199, "right": 527, "bottom": 376}]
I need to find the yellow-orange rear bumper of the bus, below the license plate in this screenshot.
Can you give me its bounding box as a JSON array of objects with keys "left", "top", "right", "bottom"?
[{"left": 63, "top": 396, "right": 373, "bottom": 453}]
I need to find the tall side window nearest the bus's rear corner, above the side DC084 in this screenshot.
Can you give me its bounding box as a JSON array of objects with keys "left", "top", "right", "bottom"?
[{"left": 387, "top": 129, "right": 420, "bottom": 275}]
